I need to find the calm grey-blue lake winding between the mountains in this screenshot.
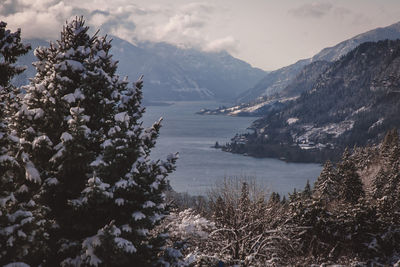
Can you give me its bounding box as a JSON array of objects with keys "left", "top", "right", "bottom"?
[{"left": 143, "top": 102, "right": 322, "bottom": 195}]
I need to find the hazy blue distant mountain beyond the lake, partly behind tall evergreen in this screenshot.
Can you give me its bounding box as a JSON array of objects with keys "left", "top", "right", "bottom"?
[{"left": 14, "top": 37, "right": 266, "bottom": 101}]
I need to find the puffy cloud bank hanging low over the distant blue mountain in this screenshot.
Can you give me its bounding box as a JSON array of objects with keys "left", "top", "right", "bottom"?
[{"left": 0, "top": 0, "right": 237, "bottom": 52}]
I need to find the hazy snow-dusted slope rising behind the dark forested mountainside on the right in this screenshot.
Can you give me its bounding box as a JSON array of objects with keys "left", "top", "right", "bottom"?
[{"left": 236, "top": 22, "right": 400, "bottom": 103}]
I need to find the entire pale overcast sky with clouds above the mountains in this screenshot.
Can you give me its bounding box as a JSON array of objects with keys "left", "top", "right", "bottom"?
[{"left": 0, "top": 0, "right": 400, "bottom": 70}]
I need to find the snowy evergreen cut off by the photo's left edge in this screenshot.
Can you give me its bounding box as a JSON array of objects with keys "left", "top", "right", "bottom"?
[{"left": 0, "top": 22, "right": 47, "bottom": 265}]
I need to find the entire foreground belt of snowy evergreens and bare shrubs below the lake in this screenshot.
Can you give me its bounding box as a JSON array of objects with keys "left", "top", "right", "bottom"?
[{"left": 0, "top": 18, "right": 400, "bottom": 267}]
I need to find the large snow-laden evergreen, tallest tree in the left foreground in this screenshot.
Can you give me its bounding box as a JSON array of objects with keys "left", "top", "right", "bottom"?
[{"left": 9, "top": 18, "right": 176, "bottom": 266}]
